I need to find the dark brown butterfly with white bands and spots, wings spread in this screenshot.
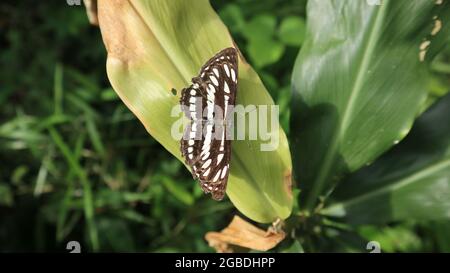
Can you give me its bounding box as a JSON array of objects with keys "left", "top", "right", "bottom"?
[{"left": 180, "top": 47, "right": 238, "bottom": 200}]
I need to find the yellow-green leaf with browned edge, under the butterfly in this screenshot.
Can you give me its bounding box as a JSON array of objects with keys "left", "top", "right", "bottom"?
[{"left": 98, "top": 0, "right": 292, "bottom": 222}]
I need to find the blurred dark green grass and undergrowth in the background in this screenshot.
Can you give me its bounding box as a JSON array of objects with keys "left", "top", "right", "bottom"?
[{"left": 0, "top": 0, "right": 450, "bottom": 252}]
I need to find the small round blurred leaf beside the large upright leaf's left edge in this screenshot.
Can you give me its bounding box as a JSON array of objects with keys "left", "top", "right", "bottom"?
[{"left": 278, "top": 16, "right": 306, "bottom": 46}]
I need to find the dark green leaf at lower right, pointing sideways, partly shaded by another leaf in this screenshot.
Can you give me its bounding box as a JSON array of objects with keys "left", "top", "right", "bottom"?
[{"left": 323, "top": 95, "right": 450, "bottom": 224}]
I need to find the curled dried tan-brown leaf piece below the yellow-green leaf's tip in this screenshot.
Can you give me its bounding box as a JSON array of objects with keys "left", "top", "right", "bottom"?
[{"left": 205, "top": 216, "right": 286, "bottom": 253}]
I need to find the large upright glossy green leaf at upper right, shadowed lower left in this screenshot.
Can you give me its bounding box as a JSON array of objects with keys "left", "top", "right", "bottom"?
[{"left": 291, "top": 0, "right": 448, "bottom": 209}]
